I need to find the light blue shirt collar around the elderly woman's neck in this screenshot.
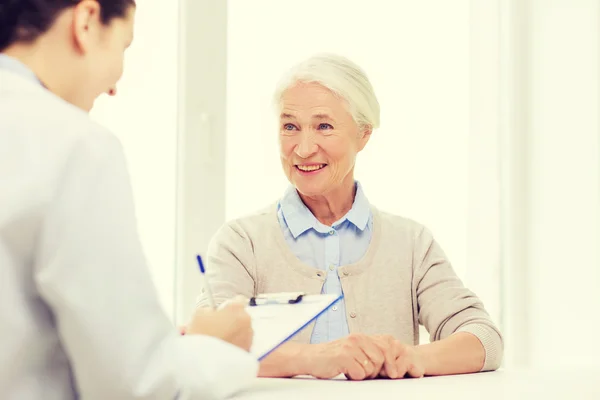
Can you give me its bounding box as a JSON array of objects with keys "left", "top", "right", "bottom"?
[{"left": 279, "top": 182, "right": 371, "bottom": 238}]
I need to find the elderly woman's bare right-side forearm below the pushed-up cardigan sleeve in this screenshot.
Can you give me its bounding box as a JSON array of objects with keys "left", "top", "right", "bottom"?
[{"left": 415, "top": 332, "right": 485, "bottom": 375}]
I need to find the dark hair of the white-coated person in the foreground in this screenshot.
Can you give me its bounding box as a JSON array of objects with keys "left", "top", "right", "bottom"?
[{"left": 0, "top": 0, "right": 135, "bottom": 51}]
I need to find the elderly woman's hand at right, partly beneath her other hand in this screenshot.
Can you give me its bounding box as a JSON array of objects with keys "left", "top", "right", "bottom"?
[{"left": 374, "top": 335, "right": 425, "bottom": 379}]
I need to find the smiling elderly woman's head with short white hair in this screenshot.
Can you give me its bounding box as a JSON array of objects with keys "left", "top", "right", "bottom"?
[{"left": 275, "top": 54, "right": 379, "bottom": 219}]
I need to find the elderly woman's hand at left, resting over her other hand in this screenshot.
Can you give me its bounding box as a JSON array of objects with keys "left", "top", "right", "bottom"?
[{"left": 304, "top": 334, "right": 396, "bottom": 380}]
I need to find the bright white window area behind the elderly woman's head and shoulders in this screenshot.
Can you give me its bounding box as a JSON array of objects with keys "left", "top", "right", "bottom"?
[{"left": 226, "top": 0, "right": 500, "bottom": 320}]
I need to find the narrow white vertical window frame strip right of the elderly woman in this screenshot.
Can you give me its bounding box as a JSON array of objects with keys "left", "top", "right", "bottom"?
[{"left": 472, "top": 0, "right": 504, "bottom": 340}]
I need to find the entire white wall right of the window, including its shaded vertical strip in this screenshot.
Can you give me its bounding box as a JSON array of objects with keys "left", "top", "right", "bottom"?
[{"left": 503, "top": 0, "right": 600, "bottom": 368}]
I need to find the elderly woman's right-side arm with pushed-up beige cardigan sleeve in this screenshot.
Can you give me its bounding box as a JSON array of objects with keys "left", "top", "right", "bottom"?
[{"left": 414, "top": 229, "right": 503, "bottom": 375}]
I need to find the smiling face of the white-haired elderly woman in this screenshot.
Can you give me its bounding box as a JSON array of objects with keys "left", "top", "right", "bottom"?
[{"left": 279, "top": 83, "right": 371, "bottom": 196}]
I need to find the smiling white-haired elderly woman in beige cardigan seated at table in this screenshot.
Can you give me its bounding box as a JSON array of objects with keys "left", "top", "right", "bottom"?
[{"left": 199, "top": 55, "right": 503, "bottom": 380}]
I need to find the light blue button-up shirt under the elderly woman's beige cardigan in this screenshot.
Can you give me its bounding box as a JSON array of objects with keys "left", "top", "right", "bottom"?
[{"left": 277, "top": 182, "right": 373, "bottom": 343}]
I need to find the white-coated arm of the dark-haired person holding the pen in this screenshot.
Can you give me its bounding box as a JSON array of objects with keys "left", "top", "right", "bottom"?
[{"left": 34, "top": 132, "right": 258, "bottom": 399}]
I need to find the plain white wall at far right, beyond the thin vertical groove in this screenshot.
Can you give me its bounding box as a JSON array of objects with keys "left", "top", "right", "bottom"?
[{"left": 527, "top": 0, "right": 600, "bottom": 366}]
